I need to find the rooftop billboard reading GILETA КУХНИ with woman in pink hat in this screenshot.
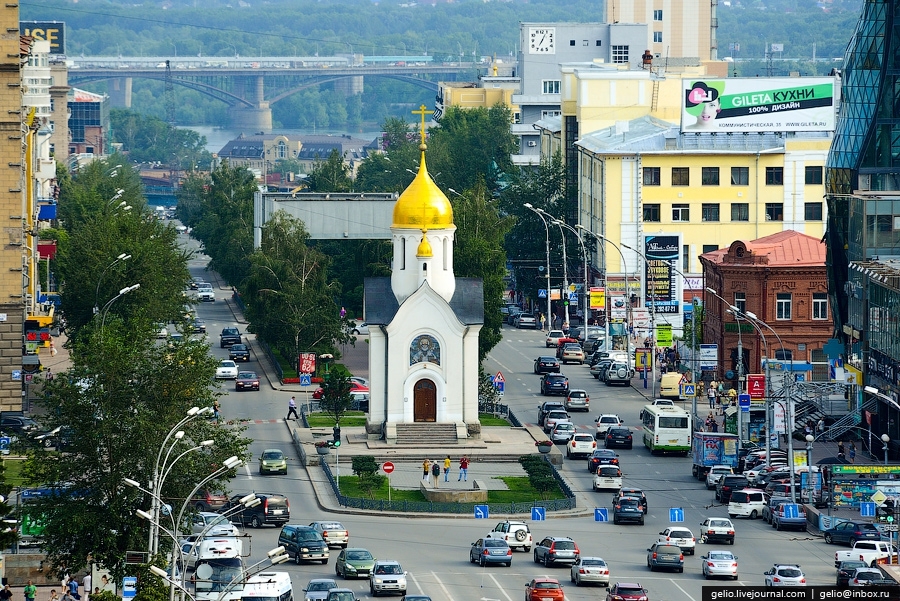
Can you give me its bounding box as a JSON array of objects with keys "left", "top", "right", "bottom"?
[{"left": 681, "top": 77, "right": 836, "bottom": 133}]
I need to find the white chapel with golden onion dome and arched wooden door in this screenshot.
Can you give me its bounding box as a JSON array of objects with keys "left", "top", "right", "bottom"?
[{"left": 364, "top": 127, "right": 484, "bottom": 442}]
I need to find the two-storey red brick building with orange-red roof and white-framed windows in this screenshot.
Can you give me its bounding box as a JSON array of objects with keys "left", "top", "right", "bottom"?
[{"left": 700, "top": 230, "right": 834, "bottom": 380}]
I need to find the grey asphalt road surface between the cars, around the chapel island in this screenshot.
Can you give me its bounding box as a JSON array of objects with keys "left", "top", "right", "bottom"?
[{"left": 181, "top": 238, "right": 839, "bottom": 601}]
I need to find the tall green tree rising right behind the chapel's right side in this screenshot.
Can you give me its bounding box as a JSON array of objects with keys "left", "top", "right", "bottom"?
[{"left": 452, "top": 180, "right": 514, "bottom": 361}]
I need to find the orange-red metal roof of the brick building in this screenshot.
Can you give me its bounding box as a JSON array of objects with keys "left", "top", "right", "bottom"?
[{"left": 701, "top": 230, "right": 826, "bottom": 267}]
